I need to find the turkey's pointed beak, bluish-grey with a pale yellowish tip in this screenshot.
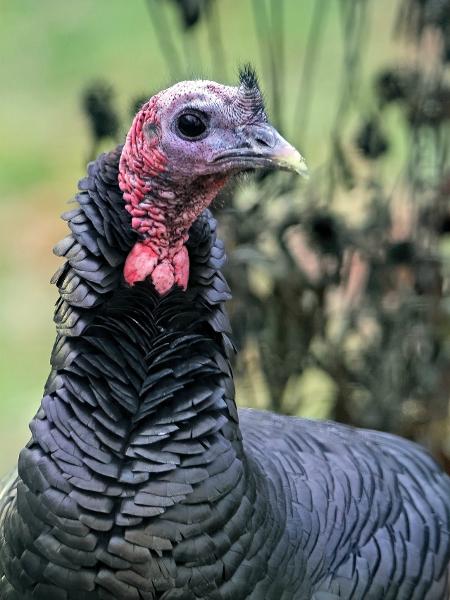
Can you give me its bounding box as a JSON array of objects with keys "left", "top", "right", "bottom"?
[{"left": 214, "top": 123, "right": 308, "bottom": 177}]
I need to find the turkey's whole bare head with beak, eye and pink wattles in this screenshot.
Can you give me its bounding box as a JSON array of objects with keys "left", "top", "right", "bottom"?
[{"left": 119, "top": 68, "right": 306, "bottom": 295}]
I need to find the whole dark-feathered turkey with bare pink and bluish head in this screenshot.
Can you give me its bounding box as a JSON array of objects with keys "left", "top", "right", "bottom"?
[{"left": 0, "top": 68, "right": 450, "bottom": 600}]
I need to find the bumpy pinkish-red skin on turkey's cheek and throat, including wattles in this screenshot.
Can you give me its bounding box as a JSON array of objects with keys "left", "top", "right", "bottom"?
[{"left": 119, "top": 84, "right": 230, "bottom": 295}]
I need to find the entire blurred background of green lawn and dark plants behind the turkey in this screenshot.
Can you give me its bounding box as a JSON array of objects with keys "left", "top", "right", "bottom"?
[{"left": 0, "top": 0, "right": 450, "bottom": 469}]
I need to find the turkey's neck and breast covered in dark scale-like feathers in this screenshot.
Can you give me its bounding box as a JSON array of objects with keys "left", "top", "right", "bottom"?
[{"left": 13, "top": 146, "right": 270, "bottom": 599}]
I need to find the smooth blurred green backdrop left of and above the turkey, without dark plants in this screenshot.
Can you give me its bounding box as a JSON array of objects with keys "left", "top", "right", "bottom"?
[{"left": 0, "top": 0, "right": 414, "bottom": 472}]
